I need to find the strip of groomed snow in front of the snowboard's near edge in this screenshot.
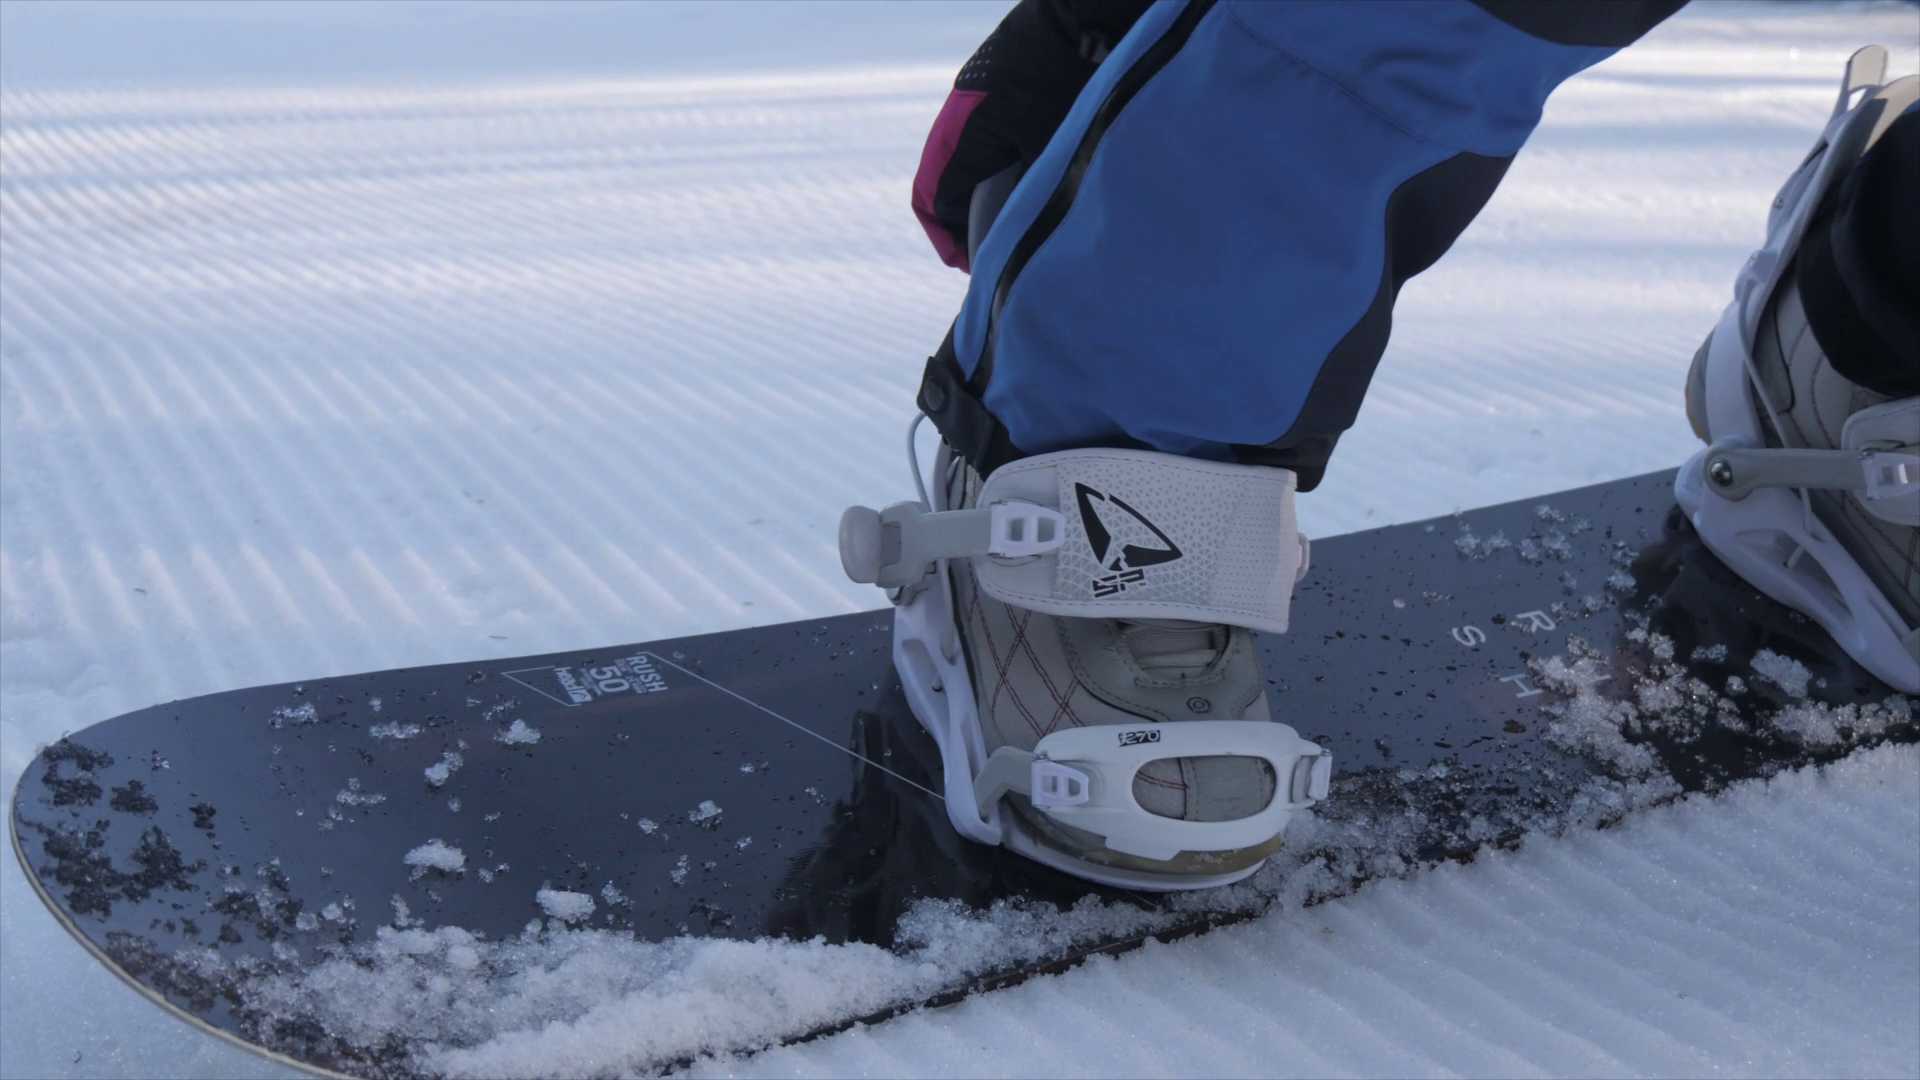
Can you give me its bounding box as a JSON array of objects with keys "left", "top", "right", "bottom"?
[{"left": 702, "top": 748, "right": 1920, "bottom": 1076}]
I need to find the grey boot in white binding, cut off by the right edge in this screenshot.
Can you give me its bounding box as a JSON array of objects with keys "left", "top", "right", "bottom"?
[{"left": 1674, "top": 46, "right": 1920, "bottom": 692}]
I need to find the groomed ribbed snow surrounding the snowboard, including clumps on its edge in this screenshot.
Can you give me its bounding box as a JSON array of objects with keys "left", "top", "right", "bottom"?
[{"left": 0, "top": 2, "right": 1920, "bottom": 1076}]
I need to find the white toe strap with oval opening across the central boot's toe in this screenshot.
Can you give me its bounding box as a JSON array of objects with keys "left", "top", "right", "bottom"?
[{"left": 973, "top": 721, "right": 1332, "bottom": 861}]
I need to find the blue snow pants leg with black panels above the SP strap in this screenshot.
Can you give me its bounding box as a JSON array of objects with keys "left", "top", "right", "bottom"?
[{"left": 920, "top": 0, "right": 1680, "bottom": 488}]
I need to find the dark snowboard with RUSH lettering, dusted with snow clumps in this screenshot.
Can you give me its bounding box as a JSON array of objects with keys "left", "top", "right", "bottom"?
[{"left": 10, "top": 473, "right": 1916, "bottom": 1076}]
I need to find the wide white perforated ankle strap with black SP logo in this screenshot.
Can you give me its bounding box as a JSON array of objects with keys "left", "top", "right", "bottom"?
[{"left": 973, "top": 450, "right": 1308, "bottom": 632}]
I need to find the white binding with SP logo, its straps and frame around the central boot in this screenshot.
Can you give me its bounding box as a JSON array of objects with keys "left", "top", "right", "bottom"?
[{"left": 839, "top": 419, "right": 1332, "bottom": 892}]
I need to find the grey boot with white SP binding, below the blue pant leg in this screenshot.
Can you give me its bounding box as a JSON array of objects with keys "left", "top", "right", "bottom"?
[{"left": 841, "top": 420, "right": 1332, "bottom": 890}]
